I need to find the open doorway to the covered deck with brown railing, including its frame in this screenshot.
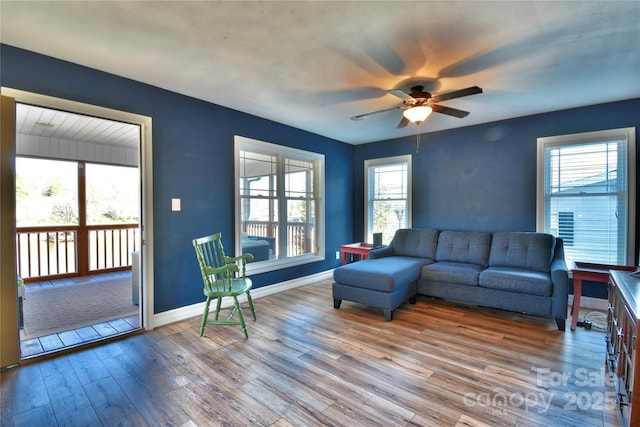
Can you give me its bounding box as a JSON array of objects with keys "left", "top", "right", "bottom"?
[{"left": 3, "top": 88, "right": 152, "bottom": 364}]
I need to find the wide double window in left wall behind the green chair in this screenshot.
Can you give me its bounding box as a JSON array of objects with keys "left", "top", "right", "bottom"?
[{"left": 235, "top": 136, "right": 324, "bottom": 273}]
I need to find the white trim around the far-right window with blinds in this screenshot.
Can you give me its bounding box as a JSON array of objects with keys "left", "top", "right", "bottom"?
[{"left": 536, "top": 127, "right": 638, "bottom": 268}]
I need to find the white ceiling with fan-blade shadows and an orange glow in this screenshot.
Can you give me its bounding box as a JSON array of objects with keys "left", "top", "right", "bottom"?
[{"left": 0, "top": 0, "right": 640, "bottom": 144}]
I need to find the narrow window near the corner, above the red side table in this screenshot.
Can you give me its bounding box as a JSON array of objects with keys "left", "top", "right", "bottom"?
[{"left": 364, "top": 155, "right": 411, "bottom": 244}]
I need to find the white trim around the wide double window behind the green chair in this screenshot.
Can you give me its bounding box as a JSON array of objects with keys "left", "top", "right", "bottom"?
[{"left": 234, "top": 135, "right": 326, "bottom": 274}]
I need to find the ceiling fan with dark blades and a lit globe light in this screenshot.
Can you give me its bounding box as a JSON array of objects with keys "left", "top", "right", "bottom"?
[{"left": 351, "top": 86, "right": 482, "bottom": 128}]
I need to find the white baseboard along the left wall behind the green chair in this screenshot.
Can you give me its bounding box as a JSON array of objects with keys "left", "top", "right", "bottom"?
[{"left": 145, "top": 270, "right": 333, "bottom": 330}]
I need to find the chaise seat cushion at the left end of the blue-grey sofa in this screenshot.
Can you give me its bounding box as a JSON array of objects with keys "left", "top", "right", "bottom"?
[{"left": 333, "top": 256, "right": 433, "bottom": 292}]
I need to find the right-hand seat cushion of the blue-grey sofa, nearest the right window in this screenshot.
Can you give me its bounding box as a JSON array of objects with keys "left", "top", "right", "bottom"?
[{"left": 480, "top": 267, "right": 553, "bottom": 297}]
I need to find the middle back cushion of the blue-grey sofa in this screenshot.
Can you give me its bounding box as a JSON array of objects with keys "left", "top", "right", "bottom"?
[{"left": 436, "top": 231, "right": 491, "bottom": 267}]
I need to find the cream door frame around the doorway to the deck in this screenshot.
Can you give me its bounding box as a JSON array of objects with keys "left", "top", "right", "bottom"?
[{"left": 0, "top": 87, "right": 154, "bottom": 364}]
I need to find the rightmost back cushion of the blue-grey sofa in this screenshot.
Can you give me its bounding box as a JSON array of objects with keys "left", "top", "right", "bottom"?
[{"left": 489, "top": 232, "right": 555, "bottom": 273}]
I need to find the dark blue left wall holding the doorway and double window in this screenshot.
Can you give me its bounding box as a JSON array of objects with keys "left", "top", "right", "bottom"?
[{"left": 0, "top": 45, "right": 353, "bottom": 313}]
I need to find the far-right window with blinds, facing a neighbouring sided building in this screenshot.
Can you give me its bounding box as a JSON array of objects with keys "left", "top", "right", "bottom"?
[{"left": 537, "top": 128, "right": 636, "bottom": 267}]
